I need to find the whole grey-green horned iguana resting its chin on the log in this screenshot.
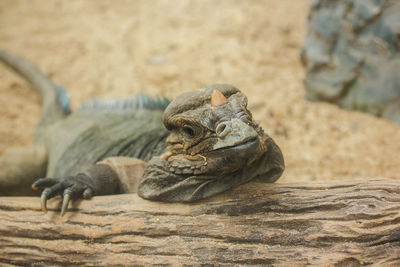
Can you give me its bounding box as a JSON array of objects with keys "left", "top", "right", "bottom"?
[{"left": 0, "top": 50, "right": 285, "bottom": 215}]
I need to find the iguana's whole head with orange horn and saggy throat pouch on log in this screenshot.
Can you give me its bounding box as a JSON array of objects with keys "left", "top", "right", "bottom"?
[{"left": 138, "top": 84, "right": 284, "bottom": 201}]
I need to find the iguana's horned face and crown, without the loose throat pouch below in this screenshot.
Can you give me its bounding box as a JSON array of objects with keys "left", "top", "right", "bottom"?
[{"left": 162, "top": 85, "right": 266, "bottom": 175}]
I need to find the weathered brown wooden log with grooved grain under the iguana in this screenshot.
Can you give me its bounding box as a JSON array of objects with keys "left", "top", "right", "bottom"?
[{"left": 0, "top": 180, "right": 400, "bottom": 266}]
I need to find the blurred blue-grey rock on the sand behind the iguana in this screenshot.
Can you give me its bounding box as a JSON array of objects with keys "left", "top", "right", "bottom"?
[{"left": 301, "top": 0, "right": 400, "bottom": 124}]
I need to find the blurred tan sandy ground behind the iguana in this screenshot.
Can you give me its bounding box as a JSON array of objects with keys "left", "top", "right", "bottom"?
[{"left": 0, "top": 0, "right": 400, "bottom": 182}]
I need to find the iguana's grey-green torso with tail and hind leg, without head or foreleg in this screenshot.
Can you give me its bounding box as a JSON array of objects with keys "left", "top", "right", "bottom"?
[{"left": 0, "top": 50, "right": 168, "bottom": 195}]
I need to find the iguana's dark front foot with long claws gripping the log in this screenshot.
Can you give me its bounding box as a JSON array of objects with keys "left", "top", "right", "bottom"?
[{"left": 32, "top": 177, "right": 93, "bottom": 216}]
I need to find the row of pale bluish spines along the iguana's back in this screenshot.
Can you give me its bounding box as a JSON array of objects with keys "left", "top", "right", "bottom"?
[{"left": 80, "top": 93, "right": 170, "bottom": 110}]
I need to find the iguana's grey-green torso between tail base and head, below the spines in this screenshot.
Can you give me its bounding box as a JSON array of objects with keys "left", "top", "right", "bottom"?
[{"left": 46, "top": 109, "right": 168, "bottom": 177}]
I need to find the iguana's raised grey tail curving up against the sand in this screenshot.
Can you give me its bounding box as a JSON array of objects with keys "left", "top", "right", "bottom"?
[{"left": 0, "top": 49, "right": 70, "bottom": 141}]
